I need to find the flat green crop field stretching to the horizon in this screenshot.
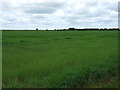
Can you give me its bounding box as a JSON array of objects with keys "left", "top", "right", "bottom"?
[{"left": 2, "top": 31, "right": 118, "bottom": 88}]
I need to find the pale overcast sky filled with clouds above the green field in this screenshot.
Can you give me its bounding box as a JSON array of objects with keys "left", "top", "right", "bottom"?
[{"left": 0, "top": 0, "right": 119, "bottom": 29}]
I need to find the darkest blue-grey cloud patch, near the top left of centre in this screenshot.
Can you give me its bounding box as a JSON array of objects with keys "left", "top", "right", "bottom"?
[{"left": 22, "top": 2, "right": 64, "bottom": 14}]
